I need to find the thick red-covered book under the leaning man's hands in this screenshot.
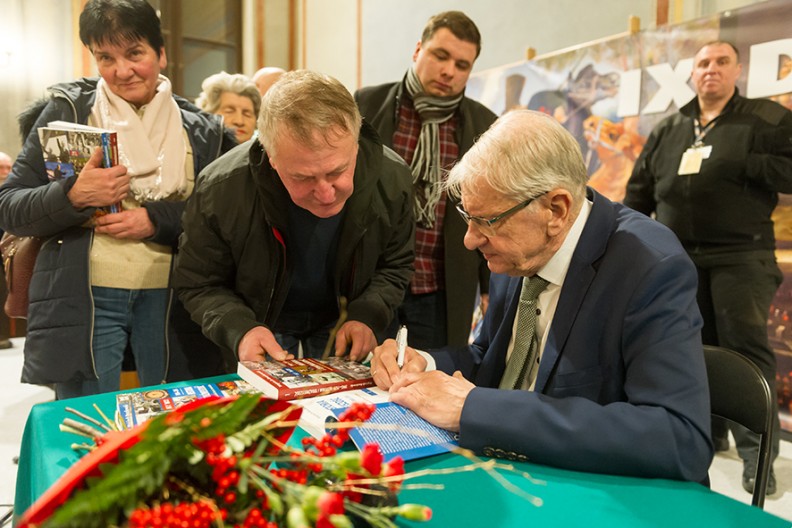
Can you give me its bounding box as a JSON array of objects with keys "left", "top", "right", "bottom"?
[{"left": 237, "top": 357, "right": 374, "bottom": 400}]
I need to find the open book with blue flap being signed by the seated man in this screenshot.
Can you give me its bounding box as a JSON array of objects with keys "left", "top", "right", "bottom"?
[{"left": 294, "top": 387, "right": 459, "bottom": 461}]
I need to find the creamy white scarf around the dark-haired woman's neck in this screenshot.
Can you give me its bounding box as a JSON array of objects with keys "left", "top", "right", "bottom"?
[{"left": 91, "top": 75, "right": 187, "bottom": 203}]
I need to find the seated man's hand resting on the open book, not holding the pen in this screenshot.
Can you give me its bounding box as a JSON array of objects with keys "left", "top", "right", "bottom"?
[{"left": 390, "top": 372, "right": 476, "bottom": 432}]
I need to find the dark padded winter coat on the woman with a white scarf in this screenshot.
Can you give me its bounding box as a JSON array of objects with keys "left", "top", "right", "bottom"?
[{"left": 0, "top": 78, "right": 234, "bottom": 384}]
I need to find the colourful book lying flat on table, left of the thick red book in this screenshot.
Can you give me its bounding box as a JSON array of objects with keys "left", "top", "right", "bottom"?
[{"left": 115, "top": 380, "right": 257, "bottom": 429}]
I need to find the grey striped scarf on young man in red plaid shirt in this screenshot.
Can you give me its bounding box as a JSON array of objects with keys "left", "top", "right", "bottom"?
[{"left": 404, "top": 66, "right": 464, "bottom": 227}]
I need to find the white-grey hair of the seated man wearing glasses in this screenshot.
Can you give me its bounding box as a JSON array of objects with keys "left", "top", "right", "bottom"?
[{"left": 446, "top": 110, "right": 588, "bottom": 203}]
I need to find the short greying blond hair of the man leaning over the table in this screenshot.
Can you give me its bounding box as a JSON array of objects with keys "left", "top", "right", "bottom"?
[{"left": 258, "top": 70, "right": 362, "bottom": 157}]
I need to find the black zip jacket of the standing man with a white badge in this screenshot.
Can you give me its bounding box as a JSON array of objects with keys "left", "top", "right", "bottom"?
[{"left": 624, "top": 92, "right": 792, "bottom": 253}]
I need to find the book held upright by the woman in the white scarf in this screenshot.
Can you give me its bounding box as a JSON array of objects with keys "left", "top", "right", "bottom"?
[{"left": 38, "top": 121, "right": 123, "bottom": 215}]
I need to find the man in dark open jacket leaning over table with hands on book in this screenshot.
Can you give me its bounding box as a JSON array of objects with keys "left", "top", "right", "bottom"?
[{"left": 174, "top": 71, "right": 415, "bottom": 361}]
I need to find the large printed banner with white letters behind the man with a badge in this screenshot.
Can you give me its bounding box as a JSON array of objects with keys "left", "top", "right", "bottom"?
[{"left": 466, "top": 0, "right": 792, "bottom": 433}]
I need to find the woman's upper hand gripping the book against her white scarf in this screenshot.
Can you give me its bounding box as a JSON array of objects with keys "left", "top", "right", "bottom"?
[{"left": 67, "top": 147, "right": 129, "bottom": 209}]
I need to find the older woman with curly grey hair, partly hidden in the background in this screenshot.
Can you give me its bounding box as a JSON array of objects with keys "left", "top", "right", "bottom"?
[{"left": 195, "top": 72, "right": 261, "bottom": 143}]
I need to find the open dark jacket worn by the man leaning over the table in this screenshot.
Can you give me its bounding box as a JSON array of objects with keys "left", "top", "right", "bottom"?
[{"left": 173, "top": 124, "right": 415, "bottom": 353}]
